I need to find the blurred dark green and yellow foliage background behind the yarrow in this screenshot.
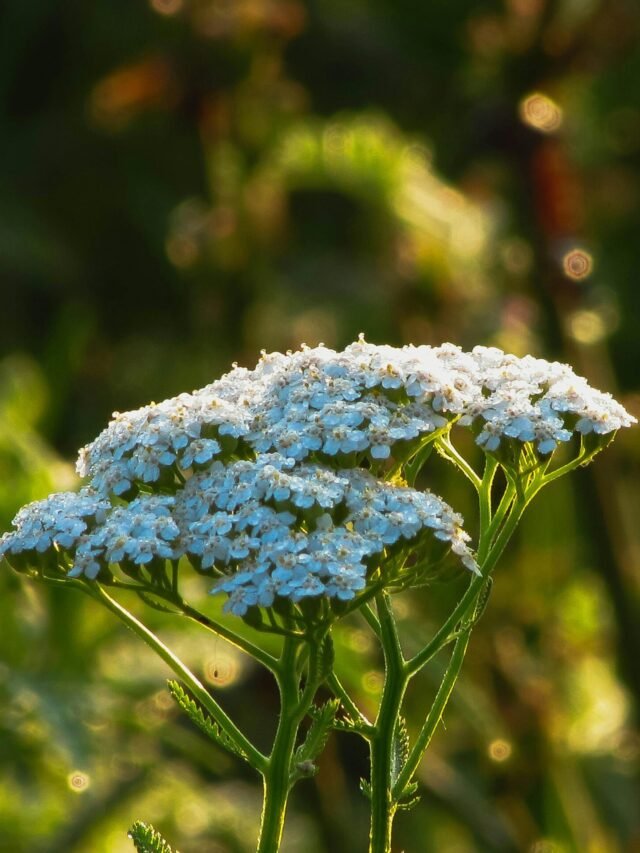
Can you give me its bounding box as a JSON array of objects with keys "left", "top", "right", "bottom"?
[{"left": 0, "top": 0, "right": 640, "bottom": 853}]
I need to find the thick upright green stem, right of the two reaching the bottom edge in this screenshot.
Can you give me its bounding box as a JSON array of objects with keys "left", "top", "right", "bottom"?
[{"left": 369, "top": 592, "right": 408, "bottom": 853}]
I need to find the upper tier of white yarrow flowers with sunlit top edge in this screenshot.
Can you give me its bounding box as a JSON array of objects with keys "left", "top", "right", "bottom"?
[{"left": 78, "top": 339, "right": 634, "bottom": 494}]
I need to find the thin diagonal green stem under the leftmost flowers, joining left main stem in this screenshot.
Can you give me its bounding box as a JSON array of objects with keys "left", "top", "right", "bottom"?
[{"left": 83, "top": 582, "right": 267, "bottom": 772}]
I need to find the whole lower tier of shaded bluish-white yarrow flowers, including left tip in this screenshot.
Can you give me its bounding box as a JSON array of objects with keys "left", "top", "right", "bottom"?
[{"left": 0, "top": 453, "right": 477, "bottom": 615}]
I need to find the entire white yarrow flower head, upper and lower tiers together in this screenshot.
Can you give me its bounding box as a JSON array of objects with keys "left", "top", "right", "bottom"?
[{"left": 0, "top": 338, "right": 634, "bottom": 615}]
